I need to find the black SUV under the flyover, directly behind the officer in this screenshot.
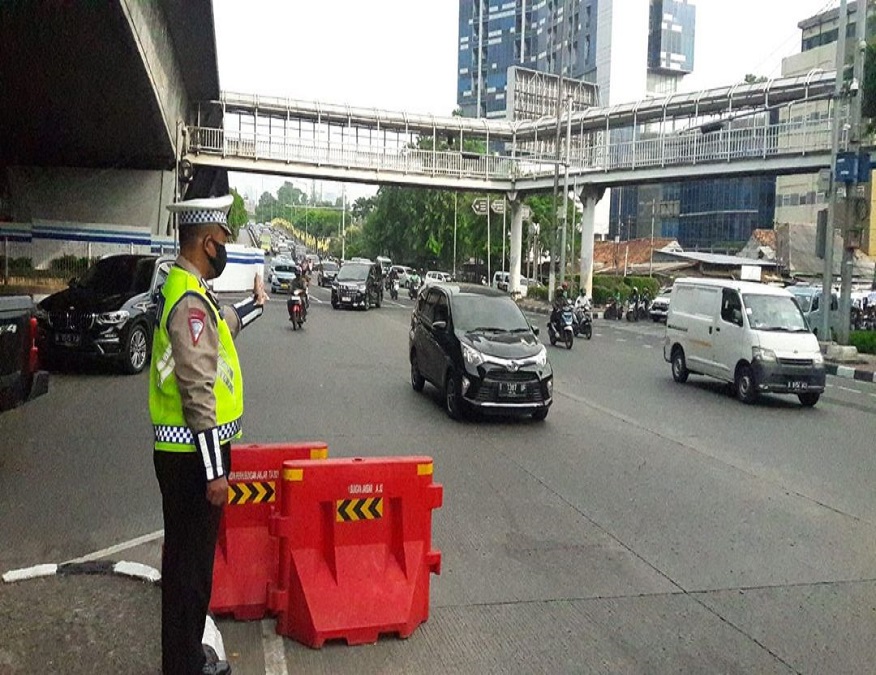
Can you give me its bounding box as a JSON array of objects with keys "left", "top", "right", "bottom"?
[{"left": 36, "top": 254, "right": 174, "bottom": 374}]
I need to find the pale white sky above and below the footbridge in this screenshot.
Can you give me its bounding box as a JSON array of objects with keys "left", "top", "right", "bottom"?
[{"left": 213, "top": 0, "right": 836, "bottom": 199}]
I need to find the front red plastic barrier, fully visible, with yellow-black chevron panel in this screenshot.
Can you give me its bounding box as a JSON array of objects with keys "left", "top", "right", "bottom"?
[{"left": 269, "top": 457, "right": 443, "bottom": 648}]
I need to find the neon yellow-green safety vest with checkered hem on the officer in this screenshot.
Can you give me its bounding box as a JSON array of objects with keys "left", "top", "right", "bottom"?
[{"left": 149, "top": 266, "right": 243, "bottom": 452}]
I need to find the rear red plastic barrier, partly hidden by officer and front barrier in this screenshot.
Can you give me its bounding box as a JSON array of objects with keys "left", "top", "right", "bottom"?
[{"left": 210, "top": 442, "right": 328, "bottom": 620}]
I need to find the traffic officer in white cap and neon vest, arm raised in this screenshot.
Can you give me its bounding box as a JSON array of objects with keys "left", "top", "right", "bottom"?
[{"left": 149, "top": 195, "right": 267, "bottom": 675}]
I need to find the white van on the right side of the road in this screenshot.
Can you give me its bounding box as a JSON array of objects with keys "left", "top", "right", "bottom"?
[{"left": 663, "top": 279, "right": 825, "bottom": 406}]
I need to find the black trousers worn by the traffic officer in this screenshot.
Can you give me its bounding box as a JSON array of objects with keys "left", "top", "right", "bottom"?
[{"left": 153, "top": 443, "right": 231, "bottom": 675}]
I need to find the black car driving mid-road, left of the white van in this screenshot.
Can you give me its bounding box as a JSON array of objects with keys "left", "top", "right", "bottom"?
[{"left": 408, "top": 283, "right": 553, "bottom": 420}]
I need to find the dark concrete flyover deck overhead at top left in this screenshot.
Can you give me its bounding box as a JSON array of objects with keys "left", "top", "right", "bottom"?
[{"left": 0, "top": 0, "right": 219, "bottom": 169}]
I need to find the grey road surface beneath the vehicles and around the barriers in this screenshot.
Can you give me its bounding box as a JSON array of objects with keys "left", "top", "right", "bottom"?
[{"left": 0, "top": 282, "right": 876, "bottom": 675}]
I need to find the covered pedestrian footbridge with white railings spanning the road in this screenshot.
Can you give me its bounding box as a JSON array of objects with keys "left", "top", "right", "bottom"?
[{"left": 184, "top": 71, "right": 836, "bottom": 192}]
